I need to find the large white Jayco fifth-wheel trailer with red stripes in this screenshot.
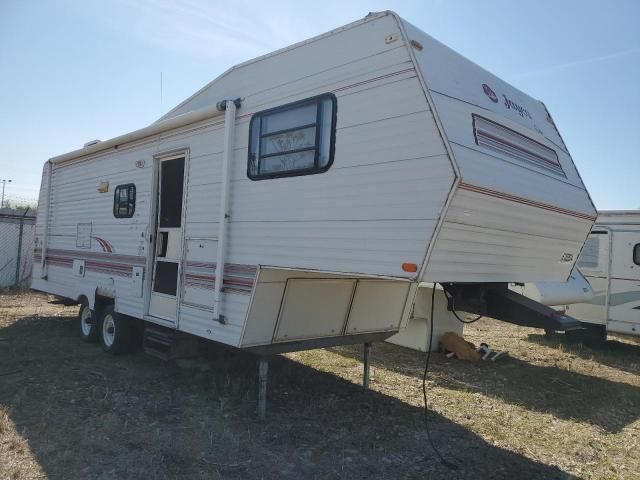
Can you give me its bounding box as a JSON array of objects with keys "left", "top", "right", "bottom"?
[{"left": 33, "top": 12, "right": 596, "bottom": 376}]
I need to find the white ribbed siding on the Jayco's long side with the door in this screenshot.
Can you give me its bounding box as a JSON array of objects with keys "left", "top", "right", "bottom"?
[{"left": 34, "top": 12, "right": 454, "bottom": 345}]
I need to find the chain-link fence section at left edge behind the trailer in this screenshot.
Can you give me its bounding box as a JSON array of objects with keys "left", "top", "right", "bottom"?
[{"left": 0, "top": 209, "right": 36, "bottom": 288}]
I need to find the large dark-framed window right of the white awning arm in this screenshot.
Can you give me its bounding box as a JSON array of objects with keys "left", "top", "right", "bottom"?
[{"left": 247, "top": 94, "right": 337, "bottom": 180}]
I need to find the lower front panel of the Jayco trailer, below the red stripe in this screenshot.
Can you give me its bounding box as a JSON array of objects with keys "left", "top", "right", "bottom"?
[{"left": 425, "top": 189, "right": 592, "bottom": 282}]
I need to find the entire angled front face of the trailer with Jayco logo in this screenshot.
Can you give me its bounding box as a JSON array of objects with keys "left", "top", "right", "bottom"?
[{"left": 403, "top": 17, "right": 595, "bottom": 282}]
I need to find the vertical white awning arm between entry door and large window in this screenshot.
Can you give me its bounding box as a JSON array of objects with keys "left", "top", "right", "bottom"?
[{"left": 213, "top": 98, "right": 240, "bottom": 325}]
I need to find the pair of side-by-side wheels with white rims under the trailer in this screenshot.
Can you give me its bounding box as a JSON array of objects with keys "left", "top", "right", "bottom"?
[{"left": 78, "top": 299, "right": 131, "bottom": 354}]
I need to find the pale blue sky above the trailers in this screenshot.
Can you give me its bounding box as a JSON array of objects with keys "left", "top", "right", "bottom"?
[{"left": 0, "top": 0, "right": 640, "bottom": 209}]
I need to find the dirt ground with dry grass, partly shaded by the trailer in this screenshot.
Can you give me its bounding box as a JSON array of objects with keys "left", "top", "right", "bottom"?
[{"left": 0, "top": 292, "right": 640, "bottom": 480}]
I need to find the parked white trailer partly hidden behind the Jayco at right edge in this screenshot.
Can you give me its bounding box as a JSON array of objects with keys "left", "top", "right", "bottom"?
[{"left": 564, "top": 210, "right": 640, "bottom": 337}]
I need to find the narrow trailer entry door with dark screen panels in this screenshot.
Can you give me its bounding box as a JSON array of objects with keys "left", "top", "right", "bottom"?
[{"left": 149, "top": 155, "right": 185, "bottom": 323}]
